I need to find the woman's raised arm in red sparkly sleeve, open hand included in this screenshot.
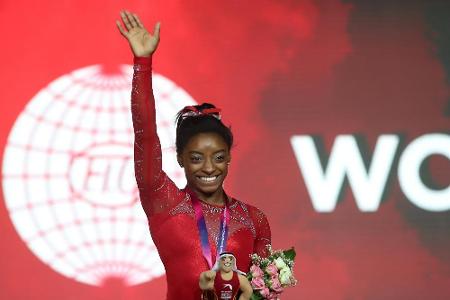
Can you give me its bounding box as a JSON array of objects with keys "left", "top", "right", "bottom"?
[{"left": 117, "top": 11, "right": 182, "bottom": 217}]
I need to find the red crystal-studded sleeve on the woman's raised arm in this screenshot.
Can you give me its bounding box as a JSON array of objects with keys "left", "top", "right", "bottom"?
[{"left": 131, "top": 57, "right": 184, "bottom": 217}]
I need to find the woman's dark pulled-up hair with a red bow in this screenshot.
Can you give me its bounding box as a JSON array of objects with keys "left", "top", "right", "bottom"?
[{"left": 175, "top": 103, "right": 233, "bottom": 155}]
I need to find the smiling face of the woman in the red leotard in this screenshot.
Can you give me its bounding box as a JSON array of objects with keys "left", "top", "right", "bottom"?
[{"left": 178, "top": 132, "right": 231, "bottom": 198}]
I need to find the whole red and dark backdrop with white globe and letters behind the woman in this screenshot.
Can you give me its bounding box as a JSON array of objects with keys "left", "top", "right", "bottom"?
[{"left": 0, "top": 0, "right": 450, "bottom": 300}]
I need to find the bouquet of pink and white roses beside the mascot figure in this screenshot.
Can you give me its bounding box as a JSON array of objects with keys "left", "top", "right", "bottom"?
[{"left": 247, "top": 245, "right": 297, "bottom": 300}]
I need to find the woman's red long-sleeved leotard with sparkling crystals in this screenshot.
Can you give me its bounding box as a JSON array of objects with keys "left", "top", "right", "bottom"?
[{"left": 131, "top": 57, "right": 271, "bottom": 300}]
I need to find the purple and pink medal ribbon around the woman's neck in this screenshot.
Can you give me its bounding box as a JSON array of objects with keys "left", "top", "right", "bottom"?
[{"left": 187, "top": 189, "right": 230, "bottom": 269}]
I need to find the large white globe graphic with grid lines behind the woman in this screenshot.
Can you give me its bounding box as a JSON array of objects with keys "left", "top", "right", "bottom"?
[{"left": 3, "top": 65, "right": 195, "bottom": 285}]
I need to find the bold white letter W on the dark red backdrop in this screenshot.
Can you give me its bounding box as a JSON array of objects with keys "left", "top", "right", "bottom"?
[{"left": 291, "top": 135, "right": 399, "bottom": 212}]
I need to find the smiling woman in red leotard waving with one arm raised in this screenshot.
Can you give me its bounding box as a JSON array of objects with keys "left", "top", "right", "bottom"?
[{"left": 117, "top": 11, "right": 271, "bottom": 299}]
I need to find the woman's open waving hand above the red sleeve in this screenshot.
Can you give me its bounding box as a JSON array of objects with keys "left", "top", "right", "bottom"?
[{"left": 116, "top": 10, "right": 161, "bottom": 57}]
